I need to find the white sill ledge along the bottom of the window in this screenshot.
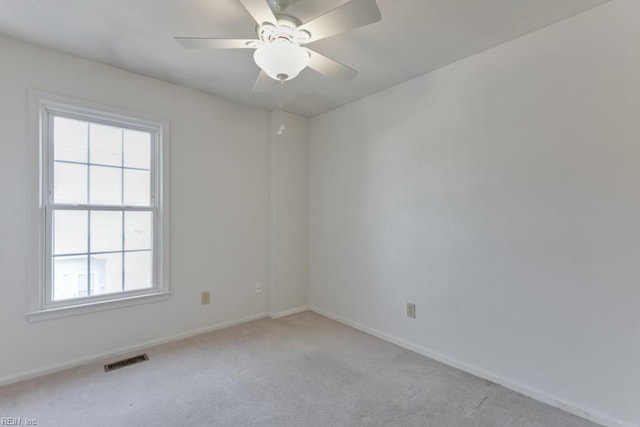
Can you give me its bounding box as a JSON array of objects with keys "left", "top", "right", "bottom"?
[{"left": 26, "top": 292, "right": 171, "bottom": 322}]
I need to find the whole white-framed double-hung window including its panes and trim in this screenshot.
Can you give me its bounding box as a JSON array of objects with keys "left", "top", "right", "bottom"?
[{"left": 30, "top": 93, "right": 168, "bottom": 317}]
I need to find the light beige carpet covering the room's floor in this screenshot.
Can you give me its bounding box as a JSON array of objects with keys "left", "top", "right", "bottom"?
[{"left": 0, "top": 312, "right": 595, "bottom": 427}]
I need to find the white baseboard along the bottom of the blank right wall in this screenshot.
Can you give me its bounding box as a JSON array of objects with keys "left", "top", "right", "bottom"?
[{"left": 308, "top": 306, "right": 635, "bottom": 427}]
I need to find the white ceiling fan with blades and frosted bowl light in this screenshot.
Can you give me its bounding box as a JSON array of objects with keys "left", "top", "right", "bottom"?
[{"left": 175, "top": 0, "right": 382, "bottom": 91}]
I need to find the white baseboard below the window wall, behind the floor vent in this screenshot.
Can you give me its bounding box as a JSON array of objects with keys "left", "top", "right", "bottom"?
[{"left": 0, "top": 313, "right": 269, "bottom": 386}]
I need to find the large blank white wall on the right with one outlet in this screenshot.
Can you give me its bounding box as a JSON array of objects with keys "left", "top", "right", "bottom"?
[{"left": 309, "top": 0, "right": 640, "bottom": 424}]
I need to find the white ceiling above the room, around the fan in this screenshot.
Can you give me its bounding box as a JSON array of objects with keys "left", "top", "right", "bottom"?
[{"left": 0, "top": 0, "right": 609, "bottom": 117}]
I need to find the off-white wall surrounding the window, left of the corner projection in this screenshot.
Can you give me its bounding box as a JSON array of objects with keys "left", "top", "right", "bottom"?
[{"left": 0, "top": 38, "right": 280, "bottom": 383}]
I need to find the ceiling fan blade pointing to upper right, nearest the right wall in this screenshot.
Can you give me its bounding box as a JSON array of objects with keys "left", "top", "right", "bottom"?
[{"left": 299, "top": 0, "right": 382, "bottom": 43}]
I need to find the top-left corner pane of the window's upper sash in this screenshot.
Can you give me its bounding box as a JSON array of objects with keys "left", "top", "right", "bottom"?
[{"left": 53, "top": 117, "right": 88, "bottom": 163}]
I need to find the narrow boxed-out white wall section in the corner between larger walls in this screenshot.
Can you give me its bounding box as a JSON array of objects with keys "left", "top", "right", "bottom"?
[{"left": 270, "top": 112, "right": 309, "bottom": 316}]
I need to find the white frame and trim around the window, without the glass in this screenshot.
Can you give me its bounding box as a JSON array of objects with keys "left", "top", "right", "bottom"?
[{"left": 27, "top": 90, "right": 171, "bottom": 321}]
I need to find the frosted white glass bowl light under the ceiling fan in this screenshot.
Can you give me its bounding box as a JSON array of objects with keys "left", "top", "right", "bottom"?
[{"left": 253, "top": 39, "right": 310, "bottom": 81}]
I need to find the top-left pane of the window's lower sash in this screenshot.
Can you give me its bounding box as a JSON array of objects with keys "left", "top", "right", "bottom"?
[{"left": 52, "top": 211, "right": 88, "bottom": 255}]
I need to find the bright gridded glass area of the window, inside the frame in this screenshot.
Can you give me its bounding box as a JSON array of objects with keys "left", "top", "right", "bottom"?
[{"left": 47, "top": 112, "right": 155, "bottom": 302}]
